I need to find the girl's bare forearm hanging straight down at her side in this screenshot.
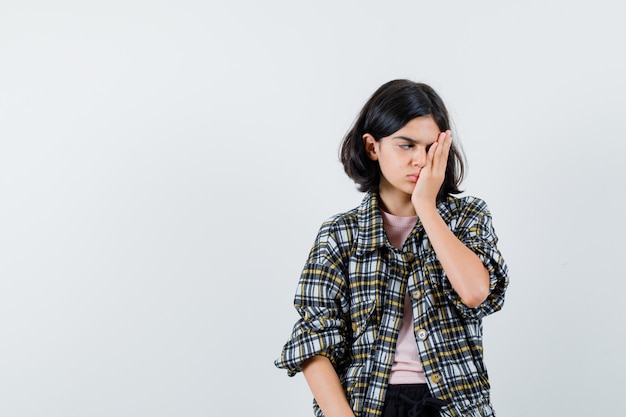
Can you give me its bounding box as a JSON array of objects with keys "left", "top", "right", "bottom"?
[{"left": 302, "top": 356, "right": 354, "bottom": 417}]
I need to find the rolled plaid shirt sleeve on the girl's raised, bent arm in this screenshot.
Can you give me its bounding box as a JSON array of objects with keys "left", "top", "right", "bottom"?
[{"left": 432, "top": 197, "right": 509, "bottom": 319}]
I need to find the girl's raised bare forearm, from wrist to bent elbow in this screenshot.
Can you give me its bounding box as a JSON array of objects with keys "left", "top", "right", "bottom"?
[{"left": 416, "top": 206, "right": 489, "bottom": 308}]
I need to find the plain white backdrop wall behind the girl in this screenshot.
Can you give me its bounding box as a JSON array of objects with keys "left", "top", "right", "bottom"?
[{"left": 0, "top": 0, "right": 626, "bottom": 417}]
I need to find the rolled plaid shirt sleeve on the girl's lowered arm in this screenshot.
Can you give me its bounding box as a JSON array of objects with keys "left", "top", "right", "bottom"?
[{"left": 274, "top": 226, "right": 348, "bottom": 376}]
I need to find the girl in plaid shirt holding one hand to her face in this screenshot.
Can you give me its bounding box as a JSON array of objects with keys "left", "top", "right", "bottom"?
[{"left": 276, "top": 80, "right": 508, "bottom": 417}]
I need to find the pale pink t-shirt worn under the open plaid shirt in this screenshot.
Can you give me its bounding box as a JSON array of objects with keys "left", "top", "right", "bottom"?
[{"left": 381, "top": 210, "right": 426, "bottom": 385}]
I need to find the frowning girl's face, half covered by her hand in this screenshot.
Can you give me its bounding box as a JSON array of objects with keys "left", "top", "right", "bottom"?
[{"left": 363, "top": 115, "right": 440, "bottom": 199}]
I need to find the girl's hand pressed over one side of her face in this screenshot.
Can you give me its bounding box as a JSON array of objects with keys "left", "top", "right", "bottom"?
[{"left": 411, "top": 130, "right": 452, "bottom": 214}]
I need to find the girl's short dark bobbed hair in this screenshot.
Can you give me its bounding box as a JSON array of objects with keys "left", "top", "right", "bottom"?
[{"left": 340, "top": 80, "right": 465, "bottom": 200}]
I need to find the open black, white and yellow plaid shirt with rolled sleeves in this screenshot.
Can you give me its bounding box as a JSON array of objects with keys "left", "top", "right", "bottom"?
[{"left": 275, "top": 193, "right": 508, "bottom": 417}]
